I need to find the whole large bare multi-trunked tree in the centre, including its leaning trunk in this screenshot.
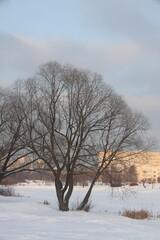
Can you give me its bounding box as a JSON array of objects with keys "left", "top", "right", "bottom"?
[{"left": 18, "top": 62, "right": 151, "bottom": 211}]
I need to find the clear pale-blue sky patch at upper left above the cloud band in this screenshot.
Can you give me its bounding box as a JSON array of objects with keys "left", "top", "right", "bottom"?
[{"left": 0, "top": 0, "right": 81, "bottom": 40}]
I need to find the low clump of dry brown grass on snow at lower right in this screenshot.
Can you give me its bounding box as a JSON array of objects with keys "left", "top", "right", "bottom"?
[{"left": 121, "top": 209, "right": 152, "bottom": 220}]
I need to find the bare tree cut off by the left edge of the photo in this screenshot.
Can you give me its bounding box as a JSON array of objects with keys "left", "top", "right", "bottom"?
[{"left": 0, "top": 85, "right": 36, "bottom": 182}]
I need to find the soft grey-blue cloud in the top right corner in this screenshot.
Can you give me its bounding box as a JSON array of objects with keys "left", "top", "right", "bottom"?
[{"left": 81, "top": 0, "right": 160, "bottom": 39}]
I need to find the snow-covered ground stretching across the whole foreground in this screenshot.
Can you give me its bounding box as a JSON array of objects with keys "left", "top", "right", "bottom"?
[{"left": 0, "top": 183, "right": 160, "bottom": 240}]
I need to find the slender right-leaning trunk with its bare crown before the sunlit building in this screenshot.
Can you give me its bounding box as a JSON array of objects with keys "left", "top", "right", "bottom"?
[{"left": 78, "top": 100, "right": 153, "bottom": 210}]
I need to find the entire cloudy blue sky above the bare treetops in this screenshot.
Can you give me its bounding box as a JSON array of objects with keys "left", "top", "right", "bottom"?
[{"left": 0, "top": 0, "right": 160, "bottom": 148}]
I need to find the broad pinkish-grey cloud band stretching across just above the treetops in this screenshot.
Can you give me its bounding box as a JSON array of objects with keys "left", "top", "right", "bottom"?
[{"left": 0, "top": 31, "right": 160, "bottom": 144}]
